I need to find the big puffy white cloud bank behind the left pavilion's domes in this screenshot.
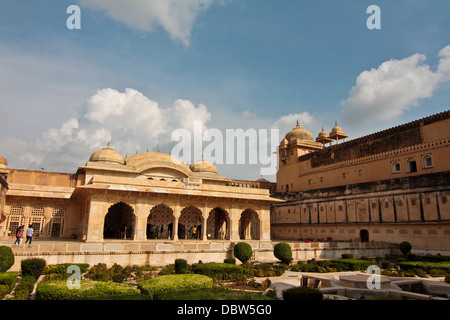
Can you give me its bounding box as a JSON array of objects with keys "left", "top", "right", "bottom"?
[{"left": 0, "top": 88, "right": 211, "bottom": 172}]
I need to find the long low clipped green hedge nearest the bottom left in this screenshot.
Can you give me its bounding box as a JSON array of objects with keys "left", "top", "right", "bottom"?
[{"left": 36, "top": 280, "right": 141, "bottom": 300}]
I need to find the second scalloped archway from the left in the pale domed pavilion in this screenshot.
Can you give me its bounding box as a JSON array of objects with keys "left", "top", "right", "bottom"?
[{"left": 147, "top": 204, "right": 175, "bottom": 239}]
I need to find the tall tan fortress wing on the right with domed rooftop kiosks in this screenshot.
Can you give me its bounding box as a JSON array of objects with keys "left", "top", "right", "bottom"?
[{"left": 271, "top": 111, "right": 450, "bottom": 253}]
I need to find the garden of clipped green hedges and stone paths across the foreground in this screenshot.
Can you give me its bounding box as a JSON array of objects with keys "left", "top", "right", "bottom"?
[{"left": 0, "top": 242, "right": 450, "bottom": 300}]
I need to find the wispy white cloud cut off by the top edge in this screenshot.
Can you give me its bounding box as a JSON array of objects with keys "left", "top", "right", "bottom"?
[{"left": 78, "top": 0, "right": 223, "bottom": 46}]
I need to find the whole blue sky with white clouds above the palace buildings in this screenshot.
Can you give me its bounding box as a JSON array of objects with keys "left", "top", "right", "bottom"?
[{"left": 0, "top": 0, "right": 450, "bottom": 180}]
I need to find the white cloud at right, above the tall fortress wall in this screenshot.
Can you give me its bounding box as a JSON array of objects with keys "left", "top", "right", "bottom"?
[{"left": 341, "top": 46, "right": 450, "bottom": 125}]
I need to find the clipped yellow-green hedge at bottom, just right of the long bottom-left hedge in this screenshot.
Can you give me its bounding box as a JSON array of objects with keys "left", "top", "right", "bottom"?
[{"left": 138, "top": 274, "right": 213, "bottom": 300}]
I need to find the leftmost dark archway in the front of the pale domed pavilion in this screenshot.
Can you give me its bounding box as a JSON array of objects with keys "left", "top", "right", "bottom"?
[{"left": 103, "top": 202, "right": 136, "bottom": 239}]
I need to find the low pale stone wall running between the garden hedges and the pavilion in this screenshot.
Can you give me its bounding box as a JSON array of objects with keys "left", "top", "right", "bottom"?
[{"left": 0, "top": 240, "right": 391, "bottom": 271}]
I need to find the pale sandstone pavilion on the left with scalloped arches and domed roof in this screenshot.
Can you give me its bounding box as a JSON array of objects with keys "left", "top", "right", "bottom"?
[{"left": 0, "top": 144, "right": 281, "bottom": 242}]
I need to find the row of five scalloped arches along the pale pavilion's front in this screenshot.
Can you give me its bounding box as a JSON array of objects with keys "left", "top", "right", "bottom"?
[{"left": 102, "top": 201, "right": 262, "bottom": 240}]
